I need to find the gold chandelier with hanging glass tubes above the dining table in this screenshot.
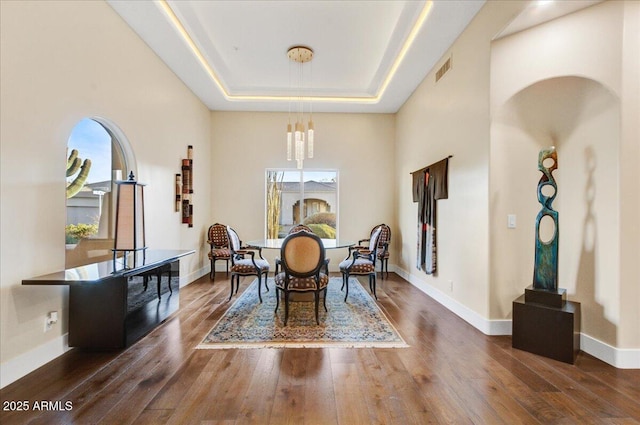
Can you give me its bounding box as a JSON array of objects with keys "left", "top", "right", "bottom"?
[{"left": 287, "top": 46, "right": 314, "bottom": 169}]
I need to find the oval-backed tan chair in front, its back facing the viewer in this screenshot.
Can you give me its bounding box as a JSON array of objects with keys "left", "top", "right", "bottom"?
[{"left": 275, "top": 231, "right": 329, "bottom": 326}]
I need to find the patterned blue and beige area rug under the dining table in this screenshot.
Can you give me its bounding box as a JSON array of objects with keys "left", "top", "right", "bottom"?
[{"left": 196, "top": 277, "right": 407, "bottom": 349}]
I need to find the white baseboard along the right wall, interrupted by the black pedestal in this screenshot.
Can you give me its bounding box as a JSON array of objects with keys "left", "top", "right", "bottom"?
[{"left": 391, "top": 265, "right": 640, "bottom": 369}]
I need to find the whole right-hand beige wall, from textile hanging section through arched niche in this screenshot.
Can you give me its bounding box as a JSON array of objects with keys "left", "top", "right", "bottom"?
[{"left": 396, "top": 1, "right": 640, "bottom": 367}]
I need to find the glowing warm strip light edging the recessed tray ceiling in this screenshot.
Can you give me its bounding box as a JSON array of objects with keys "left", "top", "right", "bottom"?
[{"left": 159, "top": 0, "right": 433, "bottom": 104}]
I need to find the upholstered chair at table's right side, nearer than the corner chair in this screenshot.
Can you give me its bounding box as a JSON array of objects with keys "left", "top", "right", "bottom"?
[{"left": 339, "top": 226, "right": 382, "bottom": 302}]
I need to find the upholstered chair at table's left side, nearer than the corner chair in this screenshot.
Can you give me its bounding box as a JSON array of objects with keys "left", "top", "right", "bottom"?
[{"left": 227, "top": 226, "right": 269, "bottom": 302}]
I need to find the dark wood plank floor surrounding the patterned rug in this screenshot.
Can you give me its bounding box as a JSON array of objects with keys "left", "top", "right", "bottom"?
[{"left": 0, "top": 273, "right": 640, "bottom": 425}]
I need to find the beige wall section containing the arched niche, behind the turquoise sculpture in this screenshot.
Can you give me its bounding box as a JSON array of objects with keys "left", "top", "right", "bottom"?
[{"left": 490, "top": 2, "right": 640, "bottom": 348}]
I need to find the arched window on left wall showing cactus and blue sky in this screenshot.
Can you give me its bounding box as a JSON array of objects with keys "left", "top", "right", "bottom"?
[{"left": 65, "top": 118, "right": 128, "bottom": 268}]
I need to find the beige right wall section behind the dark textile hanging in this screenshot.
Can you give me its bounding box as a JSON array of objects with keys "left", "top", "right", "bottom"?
[{"left": 396, "top": 2, "right": 523, "bottom": 319}]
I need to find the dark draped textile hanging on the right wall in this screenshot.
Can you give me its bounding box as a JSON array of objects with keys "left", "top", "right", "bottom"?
[{"left": 411, "top": 155, "right": 453, "bottom": 274}]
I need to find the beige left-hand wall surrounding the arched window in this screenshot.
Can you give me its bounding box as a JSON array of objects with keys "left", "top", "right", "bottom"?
[{"left": 0, "top": 1, "right": 210, "bottom": 381}]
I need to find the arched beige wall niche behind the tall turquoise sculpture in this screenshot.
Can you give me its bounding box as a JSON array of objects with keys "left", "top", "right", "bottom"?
[{"left": 490, "top": 76, "right": 621, "bottom": 345}]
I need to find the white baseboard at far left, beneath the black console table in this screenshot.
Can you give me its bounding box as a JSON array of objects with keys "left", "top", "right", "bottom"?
[{"left": 0, "top": 334, "right": 71, "bottom": 388}]
